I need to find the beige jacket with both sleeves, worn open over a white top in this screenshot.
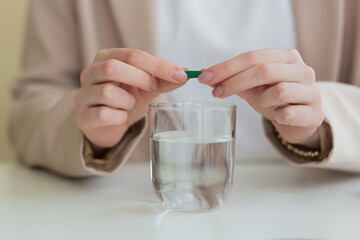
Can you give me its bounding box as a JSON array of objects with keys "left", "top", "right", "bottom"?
[{"left": 7, "top": 0, "right": 360, "bottom": 177}]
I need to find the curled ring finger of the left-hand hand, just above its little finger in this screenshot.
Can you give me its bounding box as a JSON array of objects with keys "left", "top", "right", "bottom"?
[{"left": 80, "top": 83, "right": 135, "bottom": 110}]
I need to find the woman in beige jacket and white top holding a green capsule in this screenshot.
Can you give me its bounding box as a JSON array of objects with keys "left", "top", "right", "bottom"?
[{"left": 11, "top": 0, "right": 360, "bottom": 176}]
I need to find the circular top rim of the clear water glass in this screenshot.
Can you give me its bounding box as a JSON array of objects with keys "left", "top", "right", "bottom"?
[{"left": 149, "top": 101, "right": 236, "bottom": 111}]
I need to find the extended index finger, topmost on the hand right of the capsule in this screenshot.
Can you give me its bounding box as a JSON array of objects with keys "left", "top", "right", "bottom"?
[{"left": 199, "top": 48, "right": 304, "bottom": 85}]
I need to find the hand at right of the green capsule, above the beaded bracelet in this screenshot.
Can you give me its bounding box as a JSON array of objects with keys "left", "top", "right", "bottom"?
[{"left": 199, "top": 49, "right": 324, "bottom": 146}]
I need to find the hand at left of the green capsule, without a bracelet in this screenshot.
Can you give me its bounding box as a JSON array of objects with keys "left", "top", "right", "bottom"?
[{"left": 76, "top": 48, "right": 187, "bottom": 149}]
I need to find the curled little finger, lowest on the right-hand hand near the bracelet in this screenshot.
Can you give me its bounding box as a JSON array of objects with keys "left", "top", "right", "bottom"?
[{"left": 273, "top": 105, "right": 324, "bottom": 128}]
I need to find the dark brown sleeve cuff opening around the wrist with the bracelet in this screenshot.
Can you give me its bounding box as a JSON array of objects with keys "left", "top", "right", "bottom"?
[{"left": 263, "top": 118, "right": 333, "bottom": 165}]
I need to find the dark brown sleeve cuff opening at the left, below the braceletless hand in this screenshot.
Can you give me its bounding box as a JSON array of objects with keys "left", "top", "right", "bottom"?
[{"left": 83, "top": 117, "right": 147, "bottom": 172}]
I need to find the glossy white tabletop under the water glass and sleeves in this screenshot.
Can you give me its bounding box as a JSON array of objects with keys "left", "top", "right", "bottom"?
[{"left": 0, "top": 160, "right": 360, "bottom": 240}]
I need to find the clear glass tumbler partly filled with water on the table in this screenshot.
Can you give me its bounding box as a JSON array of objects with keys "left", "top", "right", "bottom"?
[{"left": 149, "top": 102, "right": 236, "bottom": 211}]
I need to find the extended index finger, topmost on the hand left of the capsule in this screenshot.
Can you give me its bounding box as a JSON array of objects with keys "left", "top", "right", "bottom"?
[{"left": 94, "top": 48, "right": 187, "bottom": 83}]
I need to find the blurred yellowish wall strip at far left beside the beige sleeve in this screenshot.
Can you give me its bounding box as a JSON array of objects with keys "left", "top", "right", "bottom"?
[{"left": 0, "top": 0, "right": 28, "bottom": 161}]
